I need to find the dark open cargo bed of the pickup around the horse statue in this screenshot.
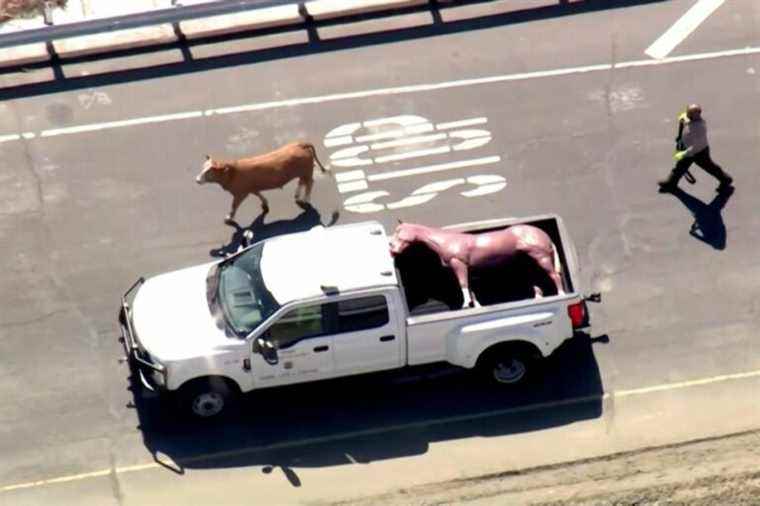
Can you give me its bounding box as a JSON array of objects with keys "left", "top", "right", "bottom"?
[{"left": 395, "top": 215, "right": 574, "bottom": 316}]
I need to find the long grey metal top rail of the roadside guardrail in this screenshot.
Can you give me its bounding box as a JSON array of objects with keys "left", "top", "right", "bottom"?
[{"left": 0, "top": 0, "right": 306, "bottom": 48}]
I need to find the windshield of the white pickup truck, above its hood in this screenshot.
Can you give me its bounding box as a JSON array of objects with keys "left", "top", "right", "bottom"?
[{"left": 213, "top": 244, "right": 280, "bottom": 336}]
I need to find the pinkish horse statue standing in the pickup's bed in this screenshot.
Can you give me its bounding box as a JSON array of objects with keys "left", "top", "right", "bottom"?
[{"left": 390, "top": 221, "right": 565, "bottom": 307}]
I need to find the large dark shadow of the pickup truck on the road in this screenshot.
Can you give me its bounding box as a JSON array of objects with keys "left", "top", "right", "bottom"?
[{"left": 133, "top": 334, "right": 606, "bottom": 474}]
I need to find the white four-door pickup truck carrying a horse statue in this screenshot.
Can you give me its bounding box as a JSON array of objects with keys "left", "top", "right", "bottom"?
[{"left": 119, "top": 215, "right": 598, "bottom": 418}]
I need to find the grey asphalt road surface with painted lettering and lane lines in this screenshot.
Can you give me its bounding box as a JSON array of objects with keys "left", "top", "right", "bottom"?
[{"left": 0, "top": 0, "right": 760, "bottom": 505}]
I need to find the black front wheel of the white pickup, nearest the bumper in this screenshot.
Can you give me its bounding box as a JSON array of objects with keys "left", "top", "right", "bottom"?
[{"left": 178, "top": 378, "right": 238, "bottom": 421}]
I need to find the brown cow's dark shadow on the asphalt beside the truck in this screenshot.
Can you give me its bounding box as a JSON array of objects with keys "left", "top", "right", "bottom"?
[{"left": 209, "top": 202, "right": 340, "bottom": 257}]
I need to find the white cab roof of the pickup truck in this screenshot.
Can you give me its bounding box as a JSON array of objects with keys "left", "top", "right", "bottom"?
[{"left": 261, "top": 221, "right": 398, "bottom": 305}]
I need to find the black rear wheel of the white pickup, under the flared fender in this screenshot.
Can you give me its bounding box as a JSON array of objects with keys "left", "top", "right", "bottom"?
[{"left": 477, "top": 346, "right": 540, "bottom": 388}]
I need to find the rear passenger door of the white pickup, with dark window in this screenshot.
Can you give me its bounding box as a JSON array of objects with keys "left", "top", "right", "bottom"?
[{"left": 333, "top": 294, "right": 405, "bottom": 376}]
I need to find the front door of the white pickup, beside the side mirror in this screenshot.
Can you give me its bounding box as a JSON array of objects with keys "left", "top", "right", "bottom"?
[{"left": 251, "top": 304, "right": 335, "bottom": 388}]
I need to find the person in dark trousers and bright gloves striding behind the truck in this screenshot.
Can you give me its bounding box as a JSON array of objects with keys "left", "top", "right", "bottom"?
[{"left": 657, "top": 104, "right": 733, "bottom": 193}]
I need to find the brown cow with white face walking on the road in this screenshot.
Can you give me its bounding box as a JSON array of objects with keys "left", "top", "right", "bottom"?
[{"left": 195, "top": 142, "right": 328, "bottom": 223}]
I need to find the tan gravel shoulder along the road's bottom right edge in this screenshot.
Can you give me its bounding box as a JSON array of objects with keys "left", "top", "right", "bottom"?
[{"left": 338, "top": 431, "right": 760, "bottom": 506}]
